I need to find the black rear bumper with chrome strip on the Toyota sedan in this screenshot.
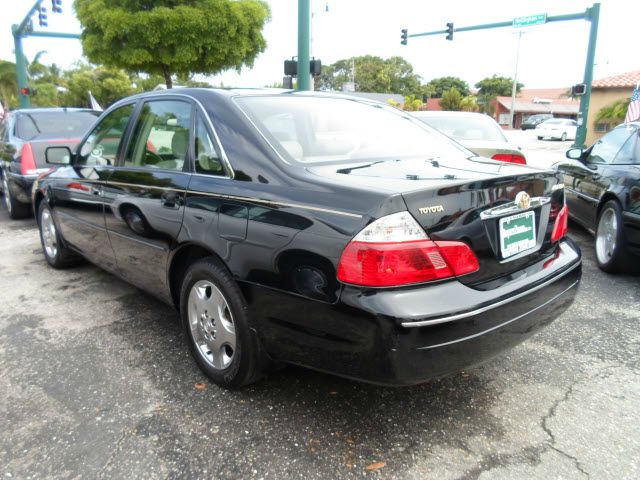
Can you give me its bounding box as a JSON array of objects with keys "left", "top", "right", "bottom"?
[{"left": 250, "top": 240, "right": 581, "bottom": 385}]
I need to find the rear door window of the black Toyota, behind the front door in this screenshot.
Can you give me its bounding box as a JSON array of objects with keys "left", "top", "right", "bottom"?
[{"left": 124, "top": 100, "right": 191, "bottom": 171}]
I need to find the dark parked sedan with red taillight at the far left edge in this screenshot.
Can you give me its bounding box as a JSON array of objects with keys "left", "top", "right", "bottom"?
[{"left": 0, "top": 108, "right": 100, "bottom": 219}]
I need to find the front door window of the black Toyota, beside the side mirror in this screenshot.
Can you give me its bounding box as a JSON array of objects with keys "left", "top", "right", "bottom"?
[{"left": 76, "top": 103, "right": 134, "bottom": 166}]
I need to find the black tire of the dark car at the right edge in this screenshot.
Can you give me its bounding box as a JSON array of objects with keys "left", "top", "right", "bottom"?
[{"left": 595, "top": 200, "right": 633, "bottom": 273}]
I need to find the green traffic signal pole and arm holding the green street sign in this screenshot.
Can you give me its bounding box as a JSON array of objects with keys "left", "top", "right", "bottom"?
[{"left": 401, "top": 3, "right": 600, "bottom": 147}]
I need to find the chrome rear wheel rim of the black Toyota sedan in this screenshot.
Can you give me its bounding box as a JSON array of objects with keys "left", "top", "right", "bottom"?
[{"left": 187, "top": 280, "right": 236, "bottom": 370}]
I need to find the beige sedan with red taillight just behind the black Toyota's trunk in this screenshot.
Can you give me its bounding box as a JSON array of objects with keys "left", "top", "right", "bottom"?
[{"left": 413, "top": 111, "right": 527, "bottom": 164}]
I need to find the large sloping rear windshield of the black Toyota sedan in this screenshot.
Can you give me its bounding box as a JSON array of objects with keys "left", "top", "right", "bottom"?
[{"left": 237, "top": 95, "right": 472, "bottom": 164}]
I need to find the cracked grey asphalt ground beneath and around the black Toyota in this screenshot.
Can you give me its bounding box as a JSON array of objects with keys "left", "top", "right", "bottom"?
[{"left": 0, "top": 199, "right": 640, "bottom": 480}]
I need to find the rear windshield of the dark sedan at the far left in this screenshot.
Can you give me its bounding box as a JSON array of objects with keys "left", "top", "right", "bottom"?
[{"left": 16, "top": 111, "right": 98, "bottom": 140}]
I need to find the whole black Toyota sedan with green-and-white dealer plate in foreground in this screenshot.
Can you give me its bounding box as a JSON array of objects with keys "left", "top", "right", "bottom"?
[{"left": 33, "top": 89, "right": 581, "bottom": 387}]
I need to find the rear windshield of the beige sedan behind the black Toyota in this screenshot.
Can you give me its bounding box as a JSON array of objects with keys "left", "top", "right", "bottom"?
[{"left": 418, "top": 115, "right": 507, "bottom": 142}]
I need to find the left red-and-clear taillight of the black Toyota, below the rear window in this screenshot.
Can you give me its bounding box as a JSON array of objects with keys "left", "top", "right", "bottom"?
[{"left": 338, "top": 212, "right": 479, "bottom": 287}]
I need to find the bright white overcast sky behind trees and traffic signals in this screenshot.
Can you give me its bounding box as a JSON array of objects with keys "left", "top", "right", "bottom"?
[{"left": 0, "top": 0, "right": 640, "bottom": 88}]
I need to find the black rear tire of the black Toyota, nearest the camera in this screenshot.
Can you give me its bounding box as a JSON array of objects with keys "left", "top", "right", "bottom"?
[{"left": 180, "top": 257, "right": 268, "bottom": 388}]
